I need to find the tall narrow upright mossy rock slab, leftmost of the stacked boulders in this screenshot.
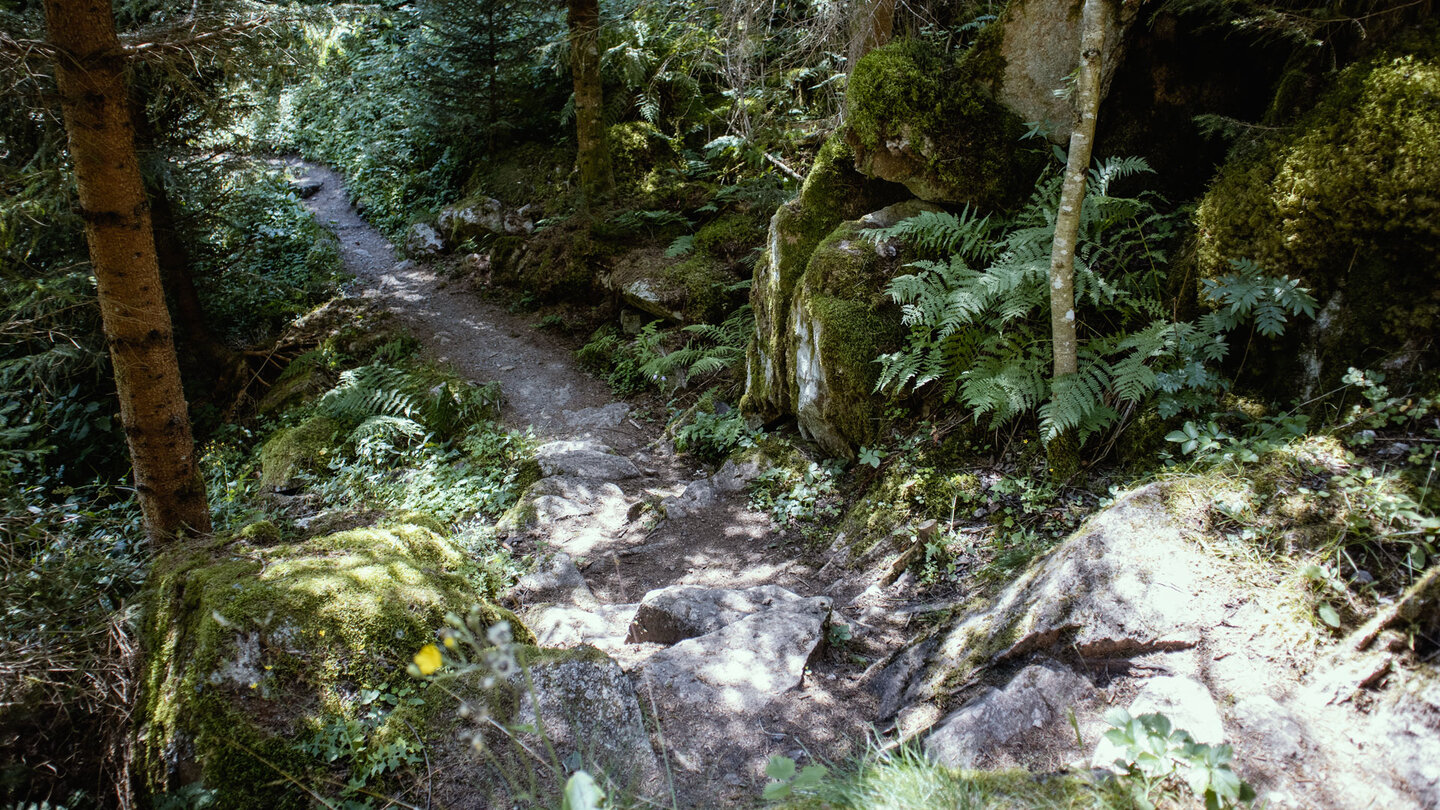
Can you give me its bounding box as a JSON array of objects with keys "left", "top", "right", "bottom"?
[{"left": 740, "top": 135, "right": 907, "bottom": 419}]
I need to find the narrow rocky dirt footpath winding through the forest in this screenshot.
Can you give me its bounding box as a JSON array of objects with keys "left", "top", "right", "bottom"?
[{"left": 289, "top": 160, "right": 903, "bottom": 807}]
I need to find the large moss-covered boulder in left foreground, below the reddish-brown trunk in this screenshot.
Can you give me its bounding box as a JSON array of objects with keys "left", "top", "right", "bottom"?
[{"left": 135, "top": 526, "right": 533, "bottom": 809}]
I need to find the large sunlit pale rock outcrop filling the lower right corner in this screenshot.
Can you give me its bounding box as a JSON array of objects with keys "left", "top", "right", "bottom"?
[{"left": 873, "top": 484, "right": 1440, "bottom": 807}]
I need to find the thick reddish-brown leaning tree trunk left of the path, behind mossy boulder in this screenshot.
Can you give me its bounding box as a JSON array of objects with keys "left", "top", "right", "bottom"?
[{"left": 45, "top": 0, "right": 210, "bottom": 542}]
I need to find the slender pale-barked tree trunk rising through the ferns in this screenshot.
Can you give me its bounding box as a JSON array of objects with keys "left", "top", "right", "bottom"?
[{"left": 1050, "top": 0, "right": 1110, "bottom": 477}]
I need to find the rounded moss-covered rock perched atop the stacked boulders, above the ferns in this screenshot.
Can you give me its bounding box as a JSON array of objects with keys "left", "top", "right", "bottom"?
[{"left": 845, "top": 37, "right": 1044, "bottom": 209}]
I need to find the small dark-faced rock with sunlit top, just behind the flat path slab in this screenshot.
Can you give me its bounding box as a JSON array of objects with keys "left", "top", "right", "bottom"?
[{"left": 626, "top": 585, "right": 805, "bottom": 644}]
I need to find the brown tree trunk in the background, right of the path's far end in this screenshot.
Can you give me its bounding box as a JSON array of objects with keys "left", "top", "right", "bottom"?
[{"left": 569, "top": 0, "right": 615, "bottom": 209}]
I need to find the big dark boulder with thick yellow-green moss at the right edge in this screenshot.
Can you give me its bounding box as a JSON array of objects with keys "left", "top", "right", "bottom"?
[{"left": 1195, "top": 25, "right": 1440, "bottom": 395}]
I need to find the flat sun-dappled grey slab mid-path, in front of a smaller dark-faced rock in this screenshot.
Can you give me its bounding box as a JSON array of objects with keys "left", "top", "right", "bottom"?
[{"left": 635, "top": 597, "right": 831, "bottom": 713}]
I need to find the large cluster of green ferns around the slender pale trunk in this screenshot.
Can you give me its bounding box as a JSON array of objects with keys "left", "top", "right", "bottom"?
[{"left": 870, "top": 159, "right": 1315, "bottom": 441}]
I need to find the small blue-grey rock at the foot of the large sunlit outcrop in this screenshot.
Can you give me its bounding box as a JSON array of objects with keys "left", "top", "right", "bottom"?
[{"left": 924, "top": 662, "right": 1096, "bottom": 768}]
